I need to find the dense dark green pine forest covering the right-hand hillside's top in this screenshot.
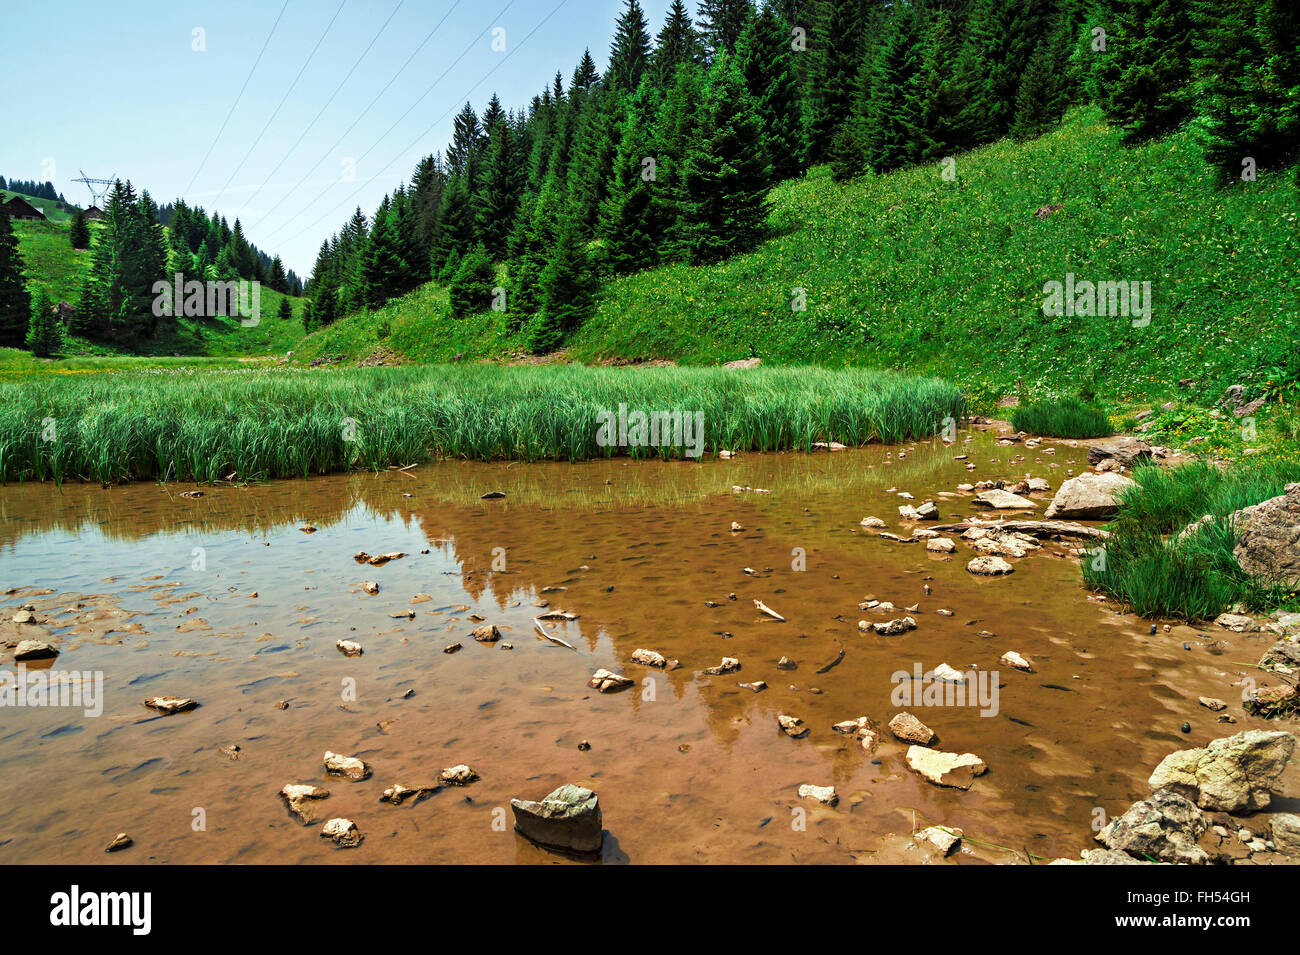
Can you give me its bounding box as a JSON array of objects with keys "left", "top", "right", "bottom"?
[{"left": 303, "top": 0, "right": 1300, "bottom": 351}]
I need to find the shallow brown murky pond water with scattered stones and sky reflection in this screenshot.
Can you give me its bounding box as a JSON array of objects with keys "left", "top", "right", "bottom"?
[{"left": 0, "top": 435, "right": 1284, "bottom": 863}]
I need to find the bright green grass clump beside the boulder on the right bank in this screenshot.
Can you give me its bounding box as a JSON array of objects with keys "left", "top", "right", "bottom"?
[{"left": 1083, "top": 460, "right": 1300, "bottom": 620}]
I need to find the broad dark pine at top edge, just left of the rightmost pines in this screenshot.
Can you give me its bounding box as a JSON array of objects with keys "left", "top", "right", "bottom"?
[{"left": 1101, "top": 0, "right": 1195, "bottom": 140}]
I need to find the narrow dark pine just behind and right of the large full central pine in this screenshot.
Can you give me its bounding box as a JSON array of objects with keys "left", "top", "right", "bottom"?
[{"left": 736, "top": 6, "right": 807, "bottom": 179}]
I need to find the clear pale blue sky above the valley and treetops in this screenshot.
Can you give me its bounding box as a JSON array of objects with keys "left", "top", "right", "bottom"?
[{"left": 10, "top": 0, "right": 676, "bottom": 278}]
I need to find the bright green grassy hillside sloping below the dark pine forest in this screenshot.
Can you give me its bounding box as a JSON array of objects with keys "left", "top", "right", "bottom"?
[{"left": 300, "top": 108, "right": 1300, "bottom": 401}]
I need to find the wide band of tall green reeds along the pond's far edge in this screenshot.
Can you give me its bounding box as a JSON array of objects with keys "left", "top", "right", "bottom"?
[{"left": 0, "top": 365, "right": 966, "bottom": 485}]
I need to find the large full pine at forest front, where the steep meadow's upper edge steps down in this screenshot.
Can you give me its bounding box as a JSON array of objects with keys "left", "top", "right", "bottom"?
[{"left": 683, "top": 53, "right": 772, "bottom": 262}]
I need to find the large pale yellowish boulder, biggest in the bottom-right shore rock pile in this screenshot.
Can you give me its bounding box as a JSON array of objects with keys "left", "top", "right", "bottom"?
[{"left": 1149, "top": 729, "right": 1296, "bottom": 812}]
